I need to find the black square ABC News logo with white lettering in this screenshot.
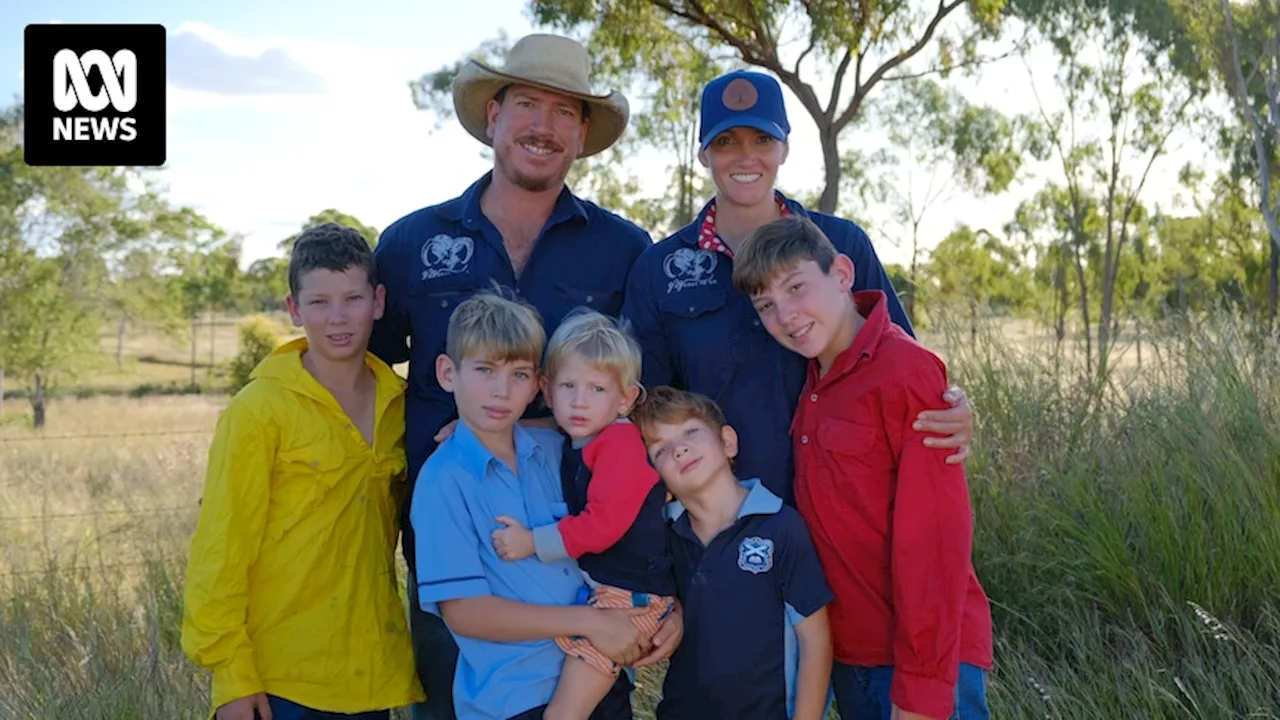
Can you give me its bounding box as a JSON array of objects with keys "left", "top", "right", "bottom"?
[{"left": 23, "top": 24, "right": 166, "bottom": 167}]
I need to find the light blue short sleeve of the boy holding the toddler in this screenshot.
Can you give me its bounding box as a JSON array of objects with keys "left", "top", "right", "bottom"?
[{"left": 410, "top": 460, "right": 493, "bottom": 615}]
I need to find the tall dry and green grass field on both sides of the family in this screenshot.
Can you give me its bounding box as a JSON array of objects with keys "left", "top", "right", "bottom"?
[{"left": 0, "top": 311, "right": 1280, "bottom": 720}]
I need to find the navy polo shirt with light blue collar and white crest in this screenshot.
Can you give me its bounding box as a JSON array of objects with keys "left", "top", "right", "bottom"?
[{"left": 658, "top": 479, "right": 835, "bottom": 720}]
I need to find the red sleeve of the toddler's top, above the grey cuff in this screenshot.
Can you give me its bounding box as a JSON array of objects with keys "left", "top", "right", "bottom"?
[{"left": 557, "top": 423, "right": 658, "bottom": 557}]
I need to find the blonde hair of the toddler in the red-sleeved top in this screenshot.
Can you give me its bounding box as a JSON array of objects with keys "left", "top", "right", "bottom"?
[{"left": 547, "top": 309, "right": 641, "bottom": 389}]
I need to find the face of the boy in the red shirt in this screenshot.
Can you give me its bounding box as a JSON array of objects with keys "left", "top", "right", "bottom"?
[{"left": 751, "top": 255, "right": 854, "bottom": 359}]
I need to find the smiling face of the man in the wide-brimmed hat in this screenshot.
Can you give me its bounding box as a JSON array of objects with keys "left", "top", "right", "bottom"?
[{"left": 489, "top": 85, "right": 589, "bottom": 192}]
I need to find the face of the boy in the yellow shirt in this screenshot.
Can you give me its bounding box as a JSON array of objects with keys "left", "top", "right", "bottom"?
[{"left": 284, "top": 268, "right": 376, "bottom": 363}]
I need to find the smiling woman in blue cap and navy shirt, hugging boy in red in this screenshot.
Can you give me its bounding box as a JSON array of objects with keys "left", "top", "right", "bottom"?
[{"left": 622, "top": 70, "right": 973, "bottom": 503}]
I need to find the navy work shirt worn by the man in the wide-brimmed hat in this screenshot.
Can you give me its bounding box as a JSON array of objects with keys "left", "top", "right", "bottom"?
[{"left": 369, "top": 172, "right": 653, "bottom": 543}]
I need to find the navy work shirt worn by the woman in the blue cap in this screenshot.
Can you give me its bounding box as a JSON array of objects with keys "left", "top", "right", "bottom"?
[{"left": 622, "top": 195, "right": 911, "bottom": 505}]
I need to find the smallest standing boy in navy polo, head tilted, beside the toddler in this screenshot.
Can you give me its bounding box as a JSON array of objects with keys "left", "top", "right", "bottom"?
[{"left": 631, "top": 387, "right": 832, "bottom": 720}]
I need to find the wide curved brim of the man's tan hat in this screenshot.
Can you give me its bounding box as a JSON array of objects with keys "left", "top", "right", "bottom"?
[{"left": 453, "top": 60, "right": 631, "bottom": 158}]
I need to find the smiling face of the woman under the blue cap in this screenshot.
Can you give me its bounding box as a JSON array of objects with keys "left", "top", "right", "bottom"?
[{"left": 698, "top": 127, "right": 787, "bottom": 208}]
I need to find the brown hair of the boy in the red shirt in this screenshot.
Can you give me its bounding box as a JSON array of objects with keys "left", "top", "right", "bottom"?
[{"left": 733, "top": 215, "right": 838, "bottom": 295}]
